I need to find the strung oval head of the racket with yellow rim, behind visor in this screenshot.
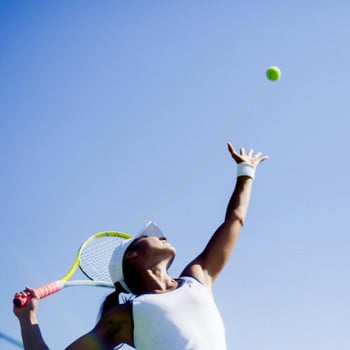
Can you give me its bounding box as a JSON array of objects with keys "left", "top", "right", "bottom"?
[{"left": 75, "top": 231, "right": 133, "bottom": 285}]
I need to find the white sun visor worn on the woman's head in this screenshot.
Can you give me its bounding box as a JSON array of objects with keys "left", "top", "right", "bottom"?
[{"left": 108, "top": 221, "right": 164, "bottom": 293}]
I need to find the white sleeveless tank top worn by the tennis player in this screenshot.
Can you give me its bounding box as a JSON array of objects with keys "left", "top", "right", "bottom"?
[{"left": 132, "top": 277, "right": 227, "bottom": 350}]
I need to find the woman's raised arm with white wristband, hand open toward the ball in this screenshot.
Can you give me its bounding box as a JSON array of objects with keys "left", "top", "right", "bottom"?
[{"left": 182, "top": 143, "right": 268, "bottom": 289}]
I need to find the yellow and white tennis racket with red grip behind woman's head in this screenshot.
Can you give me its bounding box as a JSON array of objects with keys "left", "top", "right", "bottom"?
[{"left": 13, "top": 231, "right": 132, "bottom": 308}]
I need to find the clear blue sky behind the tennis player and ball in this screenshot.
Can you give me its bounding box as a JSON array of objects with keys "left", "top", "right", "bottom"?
[{"left": 0, "top": 0, "right": 350, "bottom": 350}]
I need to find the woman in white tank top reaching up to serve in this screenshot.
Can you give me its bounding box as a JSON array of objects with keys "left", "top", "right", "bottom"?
[{"left": 14, "top": 143, "right": 268, "bottom": 350}]
